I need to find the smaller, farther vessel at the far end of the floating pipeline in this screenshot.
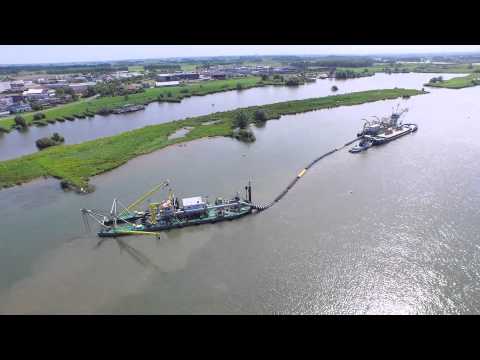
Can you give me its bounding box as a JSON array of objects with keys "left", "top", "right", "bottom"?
[{"left": 349, "top": 105, "right": 418, "bottom": 153}]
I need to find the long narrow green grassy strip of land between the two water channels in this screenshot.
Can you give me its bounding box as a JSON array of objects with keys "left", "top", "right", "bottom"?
[{"left": 0, "top": 89, "right": 422, "bottom": 188}]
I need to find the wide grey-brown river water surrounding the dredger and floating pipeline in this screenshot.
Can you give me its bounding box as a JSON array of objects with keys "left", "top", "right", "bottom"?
[{"left": 0, "top": 74, "right": 480, "bottom": 314}]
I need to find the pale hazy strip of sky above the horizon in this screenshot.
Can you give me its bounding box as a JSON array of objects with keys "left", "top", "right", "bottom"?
[{"left": 0, "top": 45, "right": 480, "bottom": 64}]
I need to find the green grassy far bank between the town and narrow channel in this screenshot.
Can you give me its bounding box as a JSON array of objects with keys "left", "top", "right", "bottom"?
[{"left": 0, "top": 76, "right": 284, "bottom": 130}]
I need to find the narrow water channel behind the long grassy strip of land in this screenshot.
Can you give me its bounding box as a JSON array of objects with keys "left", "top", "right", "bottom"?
[{"left": 0, "top": 73, "right": 459, "bottom": 160}]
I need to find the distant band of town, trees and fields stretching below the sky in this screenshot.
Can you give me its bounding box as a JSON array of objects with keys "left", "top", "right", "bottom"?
[{"left": 0, "top": 54, "right": 480, "bottom": 117}]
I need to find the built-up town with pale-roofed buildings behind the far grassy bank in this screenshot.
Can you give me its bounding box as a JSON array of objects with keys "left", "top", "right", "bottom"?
[{"left": 0, "top": 65, "right": 298, "bottom": 116}]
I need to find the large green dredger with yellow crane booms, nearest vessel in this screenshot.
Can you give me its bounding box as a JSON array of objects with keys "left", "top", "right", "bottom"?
[{"left": 81, "top": 182, "right": 254, "bottom": 237}]
